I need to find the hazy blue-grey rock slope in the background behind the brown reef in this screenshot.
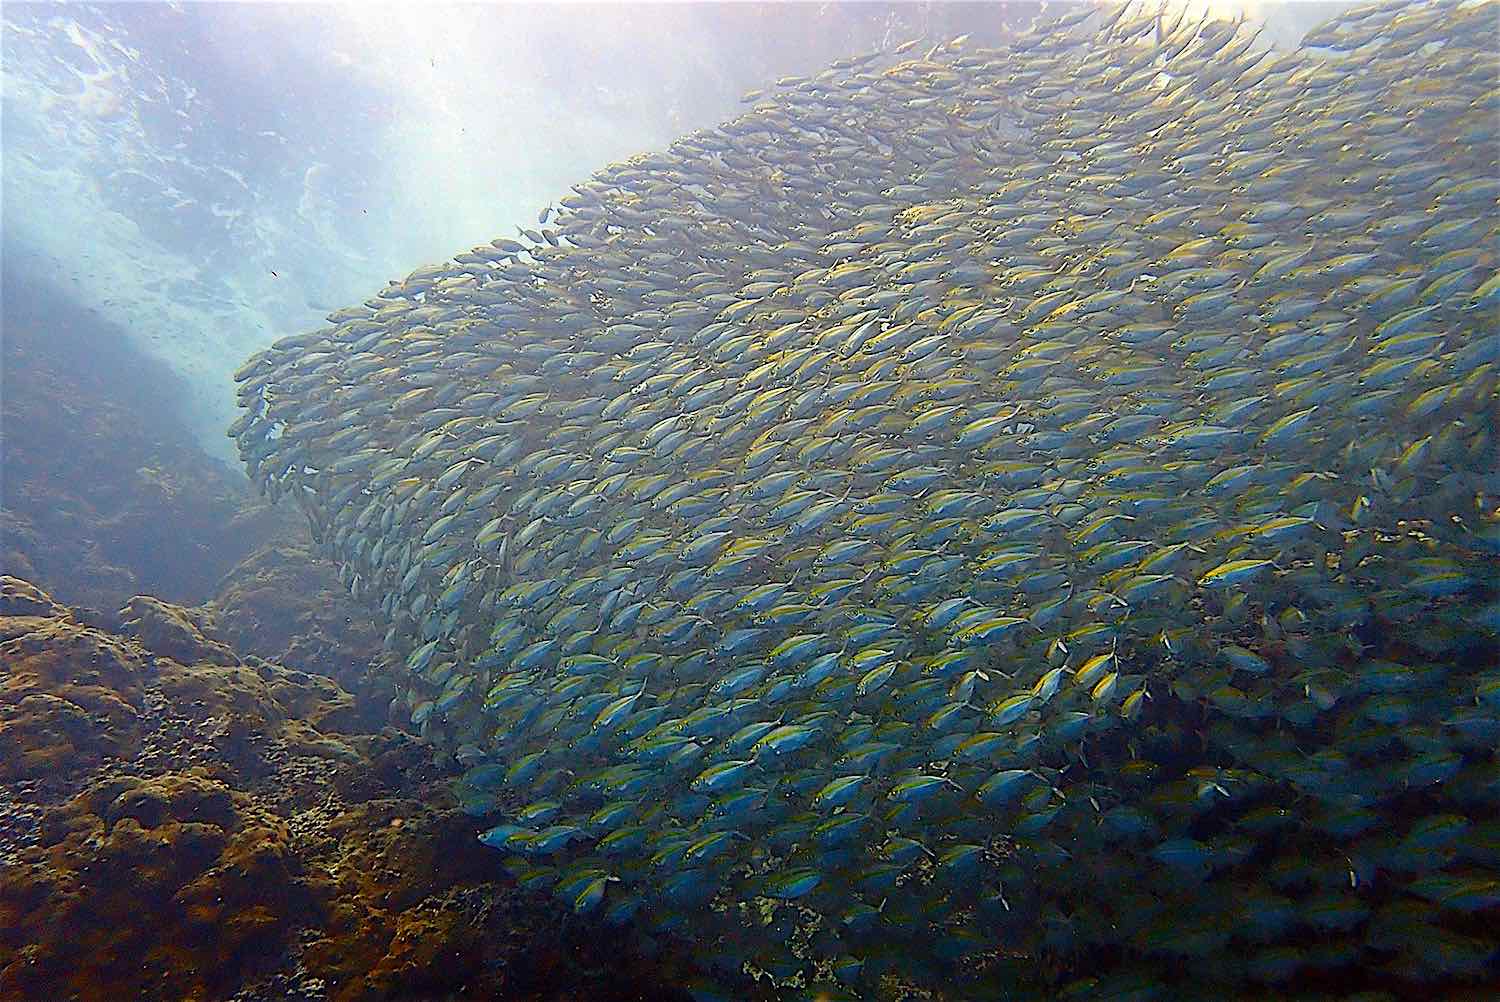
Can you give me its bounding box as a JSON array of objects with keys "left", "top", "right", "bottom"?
[{"left": 0, "top": 272, "right": 300, "bottom": 611}]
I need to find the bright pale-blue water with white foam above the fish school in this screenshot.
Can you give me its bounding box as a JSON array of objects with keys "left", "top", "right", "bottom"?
[{"left": 3, "top": 3, "right": 1056, "bottom": 458}]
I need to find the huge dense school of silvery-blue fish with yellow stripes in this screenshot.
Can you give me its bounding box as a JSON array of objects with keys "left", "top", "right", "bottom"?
[{"left": 231, "top": 0, "right": 1500, "bottom": 999}]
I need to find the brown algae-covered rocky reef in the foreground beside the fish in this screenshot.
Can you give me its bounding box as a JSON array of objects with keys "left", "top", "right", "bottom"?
[{"left": 0, "top": 579, "right": 690, "bottom": 1002}]
